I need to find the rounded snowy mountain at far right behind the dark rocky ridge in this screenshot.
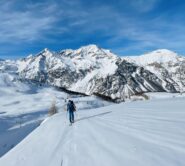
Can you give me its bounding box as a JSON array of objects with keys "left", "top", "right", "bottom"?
[{"left": 123, "top": 49, "right": 185, "bottom": 92}]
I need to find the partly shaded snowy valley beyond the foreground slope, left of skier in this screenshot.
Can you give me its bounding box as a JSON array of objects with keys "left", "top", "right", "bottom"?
[{"left": 0, "top": 73, "right": 108, "bottom": 157}]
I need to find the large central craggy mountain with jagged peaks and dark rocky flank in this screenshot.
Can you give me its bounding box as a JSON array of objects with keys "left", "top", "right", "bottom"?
[{"left": 4, "top": 45, "right": 178, "bottom": 101}]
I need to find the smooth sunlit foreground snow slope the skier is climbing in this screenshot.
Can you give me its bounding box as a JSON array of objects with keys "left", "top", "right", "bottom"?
[{"left": 0, "top": 98, "right": 185, "bottom": 166}]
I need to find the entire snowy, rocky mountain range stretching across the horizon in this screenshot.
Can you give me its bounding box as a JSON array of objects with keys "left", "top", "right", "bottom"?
[{"left": 0, "top": 45, "right": 185, "bottom": 102}]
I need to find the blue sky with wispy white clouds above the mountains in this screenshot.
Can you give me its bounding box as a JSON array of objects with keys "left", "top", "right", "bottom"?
[{"left": 0, "top": 0, "right": 185, "bottom": 58}]
